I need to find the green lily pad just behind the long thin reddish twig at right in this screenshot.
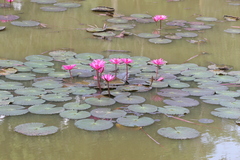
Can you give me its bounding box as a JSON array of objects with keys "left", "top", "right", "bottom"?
[{"left": 158, "top": 106, "right": 190, "bottom": 115}]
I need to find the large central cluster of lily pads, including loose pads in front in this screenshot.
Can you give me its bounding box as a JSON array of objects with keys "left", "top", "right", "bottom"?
[{"left": 0, "top": 50, "right": 240, "bottom": 139}]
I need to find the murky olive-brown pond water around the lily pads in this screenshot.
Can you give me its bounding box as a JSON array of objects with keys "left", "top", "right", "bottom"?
[{"left": 0, "top": 0, "right": 240, "bottom": 160}]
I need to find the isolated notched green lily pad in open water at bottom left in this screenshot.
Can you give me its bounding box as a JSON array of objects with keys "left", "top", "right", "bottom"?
[{"left": 14, "top": 123, "right": 58, "bottom": 136}]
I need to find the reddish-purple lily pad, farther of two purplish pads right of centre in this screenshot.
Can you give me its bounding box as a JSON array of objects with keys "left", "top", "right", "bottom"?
[{"left": 157, "top": 88, "right": 189, "bottom": 97}]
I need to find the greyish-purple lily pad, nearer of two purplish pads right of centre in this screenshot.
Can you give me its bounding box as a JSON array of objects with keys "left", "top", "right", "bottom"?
[{"left": 163, "top": 98, "right": 199, "bottom": 107}]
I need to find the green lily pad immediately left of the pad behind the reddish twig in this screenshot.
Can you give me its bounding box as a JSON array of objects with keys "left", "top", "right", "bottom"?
[{"left": 128, "top": 104, "right": 157, "bottom": 113}]
